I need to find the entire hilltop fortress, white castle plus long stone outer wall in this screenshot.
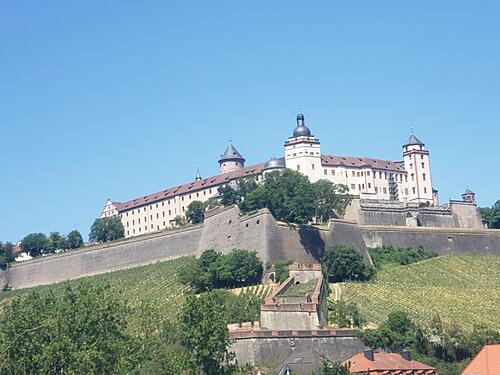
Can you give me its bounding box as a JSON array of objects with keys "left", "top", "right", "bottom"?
[{"left": 0, "top": 114, "right": 500, "bottom": 288}]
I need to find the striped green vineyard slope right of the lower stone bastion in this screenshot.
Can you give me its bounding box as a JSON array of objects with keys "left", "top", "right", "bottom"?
[{"left": 341, "top": 254, "right": 500, "bottom": 329}]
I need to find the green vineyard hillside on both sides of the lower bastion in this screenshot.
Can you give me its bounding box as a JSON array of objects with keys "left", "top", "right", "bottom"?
[{"left": 0, "top": 255, "right": 500, "bottom": 329}]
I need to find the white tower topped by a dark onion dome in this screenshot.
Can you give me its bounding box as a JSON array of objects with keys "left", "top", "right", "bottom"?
[{"left": 285, "top": 113, "right": 322, "bottom": 182}]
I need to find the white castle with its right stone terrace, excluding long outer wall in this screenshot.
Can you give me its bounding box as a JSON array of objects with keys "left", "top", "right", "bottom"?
[{"left": 100, "top": 113, "right": 482, "bottom": 237}]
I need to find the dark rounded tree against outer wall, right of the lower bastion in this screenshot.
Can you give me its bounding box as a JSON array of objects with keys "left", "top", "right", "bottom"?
[{"left": 324, "top": 246, "right": 373, "bottom": 283}]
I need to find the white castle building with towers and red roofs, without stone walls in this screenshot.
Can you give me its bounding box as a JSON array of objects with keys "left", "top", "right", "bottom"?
[{"left": 100, "top": 113, "right": 468, "bottom": 237}]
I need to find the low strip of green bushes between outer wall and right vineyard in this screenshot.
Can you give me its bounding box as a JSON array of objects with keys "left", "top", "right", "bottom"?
[{"left": 369, "top": 246, "right": 438, "bottom": 268}]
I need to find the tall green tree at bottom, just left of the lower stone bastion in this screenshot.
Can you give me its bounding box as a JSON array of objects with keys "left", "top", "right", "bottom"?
[{"left": 180, "top": 292, "right": 234, "bottom": 375}]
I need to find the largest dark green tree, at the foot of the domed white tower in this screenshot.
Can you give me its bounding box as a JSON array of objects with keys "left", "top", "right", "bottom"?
[{"left": 264, "top": 169, "right": 316, "bottom": 224}]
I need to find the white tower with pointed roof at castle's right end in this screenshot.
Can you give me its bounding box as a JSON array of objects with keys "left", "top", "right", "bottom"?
[{"left": 403, "top": 134, "right": 434, "bottom": 205}]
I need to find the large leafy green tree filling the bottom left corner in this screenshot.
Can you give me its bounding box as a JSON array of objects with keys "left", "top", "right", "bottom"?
[{"left": 0, "top": 285, "right": 131, "bottom": 374}]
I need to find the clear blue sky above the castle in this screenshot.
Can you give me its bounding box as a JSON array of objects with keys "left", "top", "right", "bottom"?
[{"left": 0, "top": 0, "right": 500, "bottom": 241}]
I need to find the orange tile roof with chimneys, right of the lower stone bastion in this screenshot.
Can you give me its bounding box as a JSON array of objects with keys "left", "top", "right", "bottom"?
[{"left": 343, "top": 351, "right": 437, "bottom": 375}]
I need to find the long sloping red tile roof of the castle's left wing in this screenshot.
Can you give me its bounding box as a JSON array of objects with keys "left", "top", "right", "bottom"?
[{"left": 113, "top": 163, "right": 264, "bottom": 212}]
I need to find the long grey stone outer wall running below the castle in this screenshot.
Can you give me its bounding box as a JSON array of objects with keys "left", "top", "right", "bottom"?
[{"left": 0, "top": 207, "right": 500, "bottom": 288}]
